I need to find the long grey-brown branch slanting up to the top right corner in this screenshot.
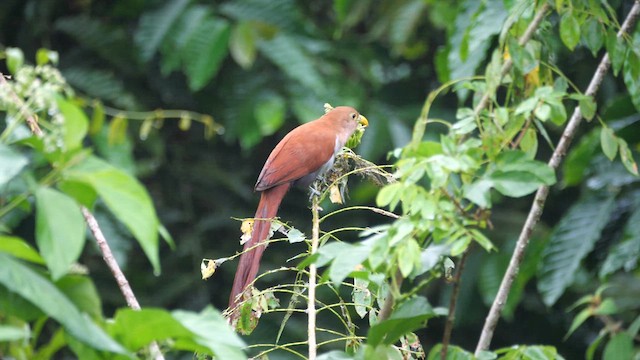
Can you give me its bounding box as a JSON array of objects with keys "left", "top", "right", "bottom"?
[{"left": 475, "top": 0, "right": 640, "bottom": 356}]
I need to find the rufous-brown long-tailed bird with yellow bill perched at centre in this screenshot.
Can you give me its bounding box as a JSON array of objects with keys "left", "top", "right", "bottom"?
[{"left": 229, "top": 106, "right": 368, "bottom": 309}]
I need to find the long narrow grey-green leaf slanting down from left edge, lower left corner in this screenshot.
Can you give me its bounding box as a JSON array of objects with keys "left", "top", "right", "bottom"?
[{"left": 0, "top": 253, "right": 125, "bottom": 353}]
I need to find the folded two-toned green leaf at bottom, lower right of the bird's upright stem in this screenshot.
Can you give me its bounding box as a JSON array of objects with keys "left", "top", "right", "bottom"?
[{"left": 367, "top": 296, "right": 437, "bottom": 346}]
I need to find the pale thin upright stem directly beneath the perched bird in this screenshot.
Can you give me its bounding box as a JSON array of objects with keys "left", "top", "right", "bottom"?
[{"left": 307, "top": 196, "right": 320, "bottom": 360}]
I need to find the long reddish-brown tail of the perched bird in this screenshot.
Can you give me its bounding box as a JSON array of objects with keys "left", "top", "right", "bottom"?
[{"left": 229, "top": 183, "right": 290, "bottom": 309}]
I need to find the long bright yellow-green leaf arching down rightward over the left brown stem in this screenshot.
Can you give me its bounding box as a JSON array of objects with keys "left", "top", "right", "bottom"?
[{"left": 64, "top": 157, "right": 160, "bottom": 273}]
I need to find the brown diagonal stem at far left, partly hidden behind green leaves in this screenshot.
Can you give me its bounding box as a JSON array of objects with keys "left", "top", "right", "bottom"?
[{"left": 0, "top": 73, "right": 164, "bottom": 360}]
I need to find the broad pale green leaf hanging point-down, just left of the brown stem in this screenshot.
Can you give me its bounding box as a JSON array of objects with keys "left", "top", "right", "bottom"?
[{"left": 35, "top": 187, "right": 85, "bottom": 280}]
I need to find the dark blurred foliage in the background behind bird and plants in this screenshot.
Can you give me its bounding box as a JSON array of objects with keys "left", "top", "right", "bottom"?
[{"left": 0, "top": 0, "right": 640, "bottom": 358}]
